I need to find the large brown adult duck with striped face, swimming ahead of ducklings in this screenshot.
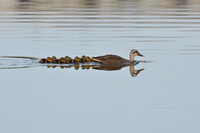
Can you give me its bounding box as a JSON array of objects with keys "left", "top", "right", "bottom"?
[{"left": 92, "top": 49, "right": 144, "bottom": 65}]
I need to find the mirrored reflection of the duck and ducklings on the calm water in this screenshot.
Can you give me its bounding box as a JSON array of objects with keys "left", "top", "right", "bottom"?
[{"left": 47, "top": 61, "right": 144, "bottom": 77}]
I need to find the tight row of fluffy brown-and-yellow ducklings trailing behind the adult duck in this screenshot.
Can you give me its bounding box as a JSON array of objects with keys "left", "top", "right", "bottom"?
[{"left": 39, "top": 55, "right": 92, "bottom": 64}]
